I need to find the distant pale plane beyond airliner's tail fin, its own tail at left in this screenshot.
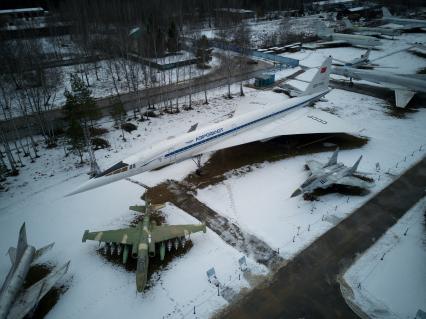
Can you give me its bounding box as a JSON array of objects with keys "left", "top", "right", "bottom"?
[{"left": 315, "top": 21, "right": 382, "bottom": 48}]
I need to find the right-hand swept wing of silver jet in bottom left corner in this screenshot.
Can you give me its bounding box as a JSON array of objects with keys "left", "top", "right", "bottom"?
[{"left": 7, "top": 262, "right": 70, "bottom": 319}]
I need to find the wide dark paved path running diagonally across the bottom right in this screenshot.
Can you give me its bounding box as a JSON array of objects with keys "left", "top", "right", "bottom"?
[{"left": 218, "top": 158, "right": 426, "bottom": 319}]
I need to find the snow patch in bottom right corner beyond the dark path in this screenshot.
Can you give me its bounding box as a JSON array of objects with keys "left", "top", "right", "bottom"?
[{"left": 344, "top": 197, "right": 426, "bottom": 319}]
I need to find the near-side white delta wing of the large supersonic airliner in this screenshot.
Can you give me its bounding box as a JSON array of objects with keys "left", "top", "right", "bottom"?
[{"left": 200, "top": 107, "right": 358, "bottom": 153}]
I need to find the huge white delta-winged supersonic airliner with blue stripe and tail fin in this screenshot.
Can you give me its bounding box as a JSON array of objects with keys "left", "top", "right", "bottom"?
[{"left": 68, "top": 57, "right": 356, "bottom": 195}]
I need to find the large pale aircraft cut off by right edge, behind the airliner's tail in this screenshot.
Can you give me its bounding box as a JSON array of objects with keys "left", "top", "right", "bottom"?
[{"left": 332, "top": 67, "right": 426, "bottom": 107}]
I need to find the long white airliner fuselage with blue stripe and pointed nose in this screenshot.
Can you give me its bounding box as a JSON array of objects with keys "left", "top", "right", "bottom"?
[{"left": 69, "top": 89, "right": 329, "bottom": 195}]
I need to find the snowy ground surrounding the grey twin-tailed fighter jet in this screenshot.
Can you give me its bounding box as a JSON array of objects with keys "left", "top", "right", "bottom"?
[{"left": 197, "top": 90, "right": 426, "bottom": 258}]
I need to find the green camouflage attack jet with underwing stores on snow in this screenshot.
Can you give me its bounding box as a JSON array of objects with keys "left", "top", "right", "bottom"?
[{"left": 82, "top": 206, "right": 206, "bottom": 292}]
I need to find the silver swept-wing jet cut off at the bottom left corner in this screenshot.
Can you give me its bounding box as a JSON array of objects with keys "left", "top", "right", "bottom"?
[{"left": 0, "top": 223, "right": 70, "bottom": 319}]
